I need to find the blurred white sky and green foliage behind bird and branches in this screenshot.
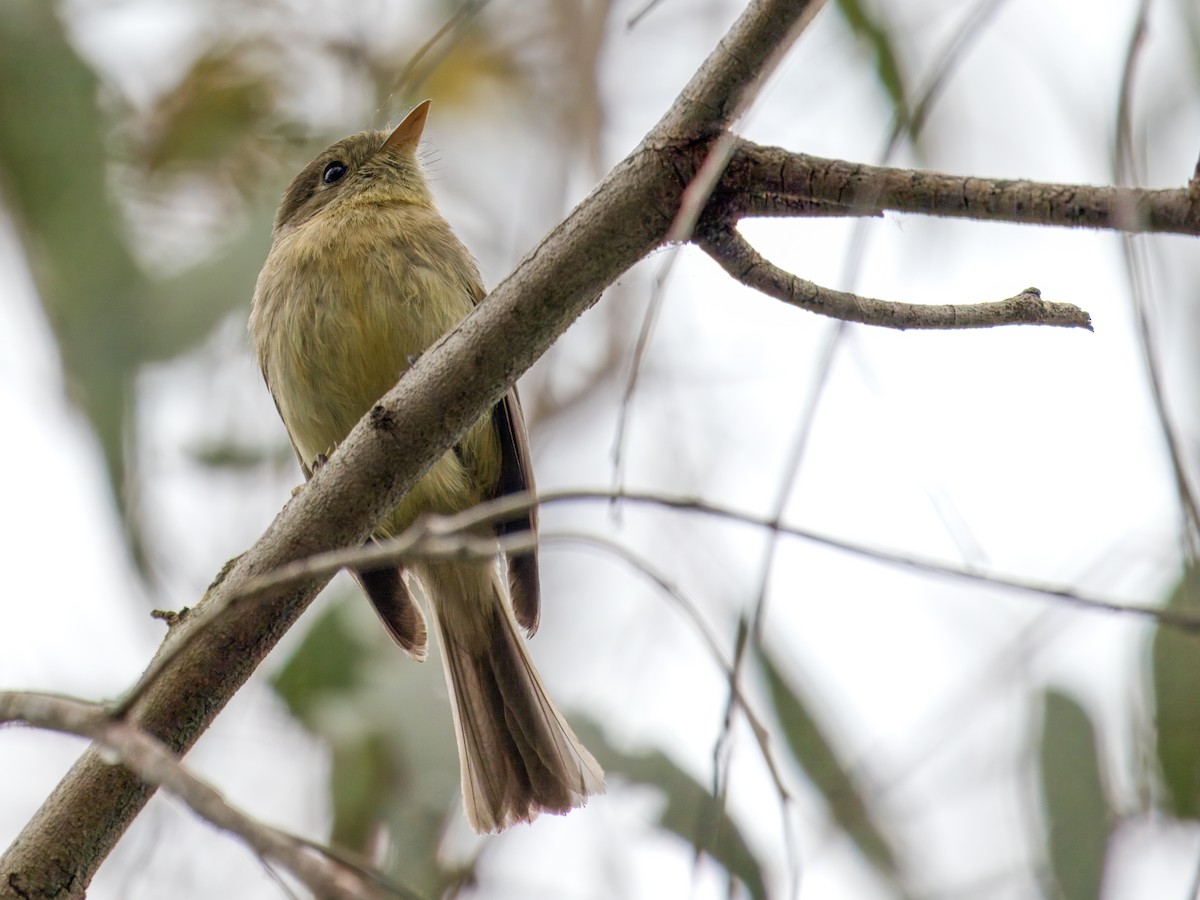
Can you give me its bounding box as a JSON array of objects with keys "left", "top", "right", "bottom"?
[{"left": 0, "top": 0, "right": 1200, "bottom": 900}]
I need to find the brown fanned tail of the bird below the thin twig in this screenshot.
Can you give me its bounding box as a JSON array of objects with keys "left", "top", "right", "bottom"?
[{"left": 418, "top": 563, "right": 605, "bottom": 832}]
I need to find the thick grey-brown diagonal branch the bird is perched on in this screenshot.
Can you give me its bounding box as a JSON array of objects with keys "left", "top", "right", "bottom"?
[{"left": 0, "top": 0, "right": 815, "bottom": 899}]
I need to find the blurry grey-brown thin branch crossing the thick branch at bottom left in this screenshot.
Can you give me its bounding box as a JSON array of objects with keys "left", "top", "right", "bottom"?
[{"left": 0, "top": 691, "right": 412, "bottom": 900}]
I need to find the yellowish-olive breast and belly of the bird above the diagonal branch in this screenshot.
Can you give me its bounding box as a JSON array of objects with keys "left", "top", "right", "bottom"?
[{"left": 251, "top": 209, "right": 479, "bottom": 463}]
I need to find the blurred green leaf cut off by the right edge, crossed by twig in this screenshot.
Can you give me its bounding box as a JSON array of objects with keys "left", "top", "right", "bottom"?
[{"left": 1151, "top": 571, "right": 1200, "bottom": 820}]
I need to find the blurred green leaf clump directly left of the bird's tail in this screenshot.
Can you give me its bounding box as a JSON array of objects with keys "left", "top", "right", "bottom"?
[{"left": 271, "top": 600, "right": 472, "bottom": 896}]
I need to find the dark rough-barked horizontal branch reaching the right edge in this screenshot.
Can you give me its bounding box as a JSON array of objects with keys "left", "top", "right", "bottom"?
[{"left": 710, "top": 140, "right": 1200, "bottom": 235}]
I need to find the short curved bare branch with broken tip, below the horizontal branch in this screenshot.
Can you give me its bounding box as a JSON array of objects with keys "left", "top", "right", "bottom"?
[{"left": 695, "top": 228, "right": 1092, "bottom": 331}]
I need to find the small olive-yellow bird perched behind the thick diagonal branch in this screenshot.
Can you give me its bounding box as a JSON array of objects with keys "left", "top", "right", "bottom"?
[{"left": 250, "top": 101, "right": 604, "bottom": 832}]
